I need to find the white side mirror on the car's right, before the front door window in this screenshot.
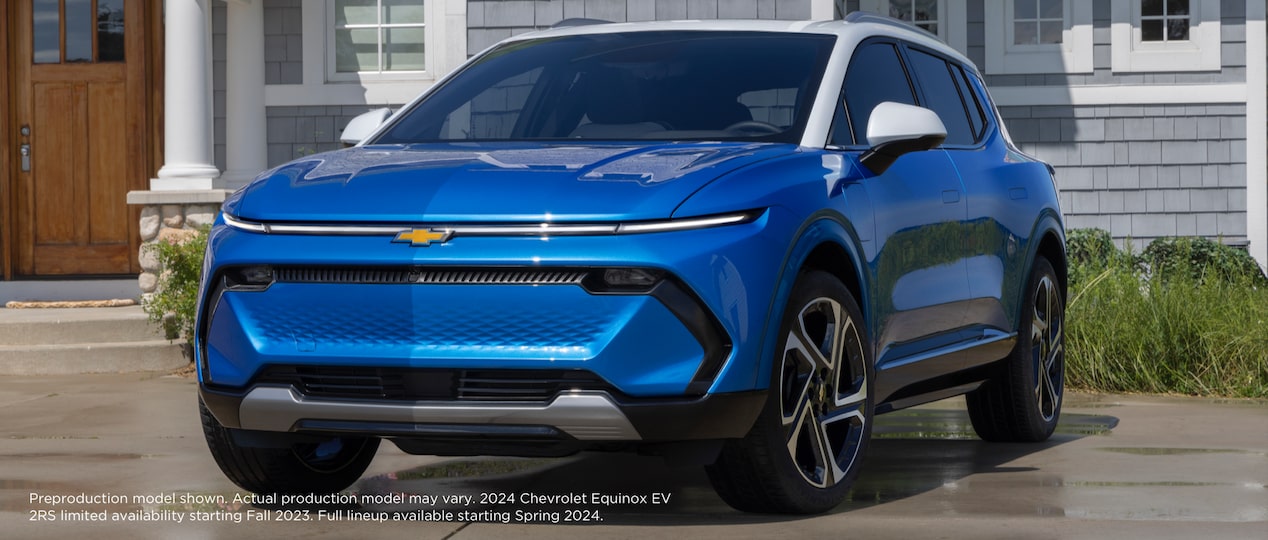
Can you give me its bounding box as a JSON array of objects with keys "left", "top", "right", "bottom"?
[{"left": 858, "top": 101, "right": 947, "bottom": 175}]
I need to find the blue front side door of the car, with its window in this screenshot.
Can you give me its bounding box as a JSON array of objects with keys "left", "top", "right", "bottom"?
[{"left": 832, "top": 41, "right": 969, "bottom": 382}]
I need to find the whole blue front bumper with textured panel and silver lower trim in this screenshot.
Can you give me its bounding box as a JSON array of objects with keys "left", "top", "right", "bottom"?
[{"left": 195, "top": 207, "right": 790, "bottom": 442}]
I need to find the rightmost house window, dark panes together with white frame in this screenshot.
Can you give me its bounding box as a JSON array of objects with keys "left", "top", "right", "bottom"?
[{"left": 1110, "top": 0, "right": 1220, "bottom": 72}]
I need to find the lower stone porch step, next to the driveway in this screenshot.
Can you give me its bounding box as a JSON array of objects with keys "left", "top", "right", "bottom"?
[{"left": 0, "top": 340, "right": 189, "bottom": 375}]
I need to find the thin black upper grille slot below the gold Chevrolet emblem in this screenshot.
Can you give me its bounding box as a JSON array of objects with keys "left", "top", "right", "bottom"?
[{"left": 276, "top": 266, "right": 588, "bottom": 285}]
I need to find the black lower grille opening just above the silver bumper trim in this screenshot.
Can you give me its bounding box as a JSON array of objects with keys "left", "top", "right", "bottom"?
[{"left": 256, "top": 366, "right": 616, "bottom": 403}]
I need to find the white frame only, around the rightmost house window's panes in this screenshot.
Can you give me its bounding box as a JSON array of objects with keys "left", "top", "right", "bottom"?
[{"left": 1110, "top": 0, "right": 1220, "bottom": 72}]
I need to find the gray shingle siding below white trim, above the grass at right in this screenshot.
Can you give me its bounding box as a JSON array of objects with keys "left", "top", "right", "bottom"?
[{"left": 1000, "top": 104, "right": 1246, "bottom": 247}]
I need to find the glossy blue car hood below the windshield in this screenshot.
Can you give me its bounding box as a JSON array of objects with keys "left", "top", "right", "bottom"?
[{"left": 224, "top": 142, "right": 796, "bottom": 223}]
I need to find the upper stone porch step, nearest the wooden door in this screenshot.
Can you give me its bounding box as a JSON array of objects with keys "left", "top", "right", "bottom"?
[{"left": 0, "top": 305, "right": 166, "bottom": 346}]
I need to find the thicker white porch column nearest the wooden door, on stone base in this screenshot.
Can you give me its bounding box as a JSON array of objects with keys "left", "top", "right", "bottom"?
[{"left": 150, "top": 0, "right": 221, "bottom": 191}]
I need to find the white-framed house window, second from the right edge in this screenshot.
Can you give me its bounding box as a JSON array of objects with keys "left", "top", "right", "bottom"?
[{"left": 984, "top": 0, "right": 1092, "bottom": 74}]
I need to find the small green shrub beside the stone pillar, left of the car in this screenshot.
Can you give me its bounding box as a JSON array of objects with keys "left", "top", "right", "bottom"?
[{"left": 145, "top": 227, "right": 207, "bottom": 342}]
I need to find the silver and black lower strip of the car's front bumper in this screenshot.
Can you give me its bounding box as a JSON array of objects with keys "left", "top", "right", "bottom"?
[{"left": 200, "top": 385, "right": 766, "bottom": 442}]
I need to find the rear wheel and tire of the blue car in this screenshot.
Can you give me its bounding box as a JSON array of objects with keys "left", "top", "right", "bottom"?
[{"left": 965, "top": 255, "right": 1065, "bottom": 442}]
